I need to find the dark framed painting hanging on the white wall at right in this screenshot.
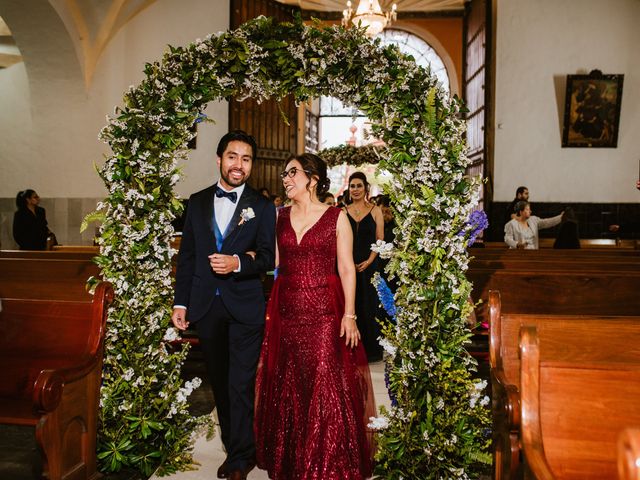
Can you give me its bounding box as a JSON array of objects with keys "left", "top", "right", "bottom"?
[{"left": 562, "top": 70, "right": 624, "bottom": 148}]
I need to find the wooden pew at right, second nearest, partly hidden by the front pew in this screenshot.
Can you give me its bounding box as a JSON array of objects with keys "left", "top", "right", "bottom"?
[{"left": 489, "top": 291, "right": 640, "bottom": 479}]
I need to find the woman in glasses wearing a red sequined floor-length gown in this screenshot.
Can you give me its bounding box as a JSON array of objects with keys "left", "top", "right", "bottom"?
[{"left": 255, "top": 154, "right": 375, "bottom": 480}]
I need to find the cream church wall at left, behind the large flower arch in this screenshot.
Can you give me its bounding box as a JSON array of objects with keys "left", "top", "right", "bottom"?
[{"left": 0, "top": 0, "right": 229, "bottom": 249}]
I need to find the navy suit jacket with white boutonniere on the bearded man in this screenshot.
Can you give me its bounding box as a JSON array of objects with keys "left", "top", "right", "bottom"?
[{"left": 174, "top": 185, "right": 276, "bottom": 324}]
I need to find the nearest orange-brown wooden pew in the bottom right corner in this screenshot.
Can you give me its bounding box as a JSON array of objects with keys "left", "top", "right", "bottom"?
[{"left": 520, "top": 319, "right": 640, "bottom": 480}]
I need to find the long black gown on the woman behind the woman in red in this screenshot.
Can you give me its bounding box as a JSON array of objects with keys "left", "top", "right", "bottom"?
[{"left": 347, "top": 208, "right": 384, "bottom": 361}]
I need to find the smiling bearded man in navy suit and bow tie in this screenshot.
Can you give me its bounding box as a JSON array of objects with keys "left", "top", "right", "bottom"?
[{"left": 171, "top": 130, "right": 275, "bottom": 480}]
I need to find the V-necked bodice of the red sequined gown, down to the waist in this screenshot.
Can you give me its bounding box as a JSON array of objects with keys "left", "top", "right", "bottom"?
[{"left": 277, "top": 207, "right": 340, "bottom": 283}]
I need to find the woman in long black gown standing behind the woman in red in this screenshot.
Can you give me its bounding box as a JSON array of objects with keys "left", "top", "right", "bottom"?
[{"left": 344, "top": 172, "right": 384, "bottom": 362}]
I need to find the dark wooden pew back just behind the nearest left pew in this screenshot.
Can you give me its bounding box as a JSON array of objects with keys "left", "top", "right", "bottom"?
[{"left": 0, "top": 258, "right": 100, "bottom": 301}]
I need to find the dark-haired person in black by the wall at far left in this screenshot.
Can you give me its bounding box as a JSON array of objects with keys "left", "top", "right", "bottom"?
[{"left": 13, "top": 188, "right": 50, "bottom": 250}]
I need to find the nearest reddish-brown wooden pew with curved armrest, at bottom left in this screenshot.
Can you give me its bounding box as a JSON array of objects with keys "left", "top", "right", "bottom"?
[{"left": 0, "top": 283, "right": 113, "bottom": 480}]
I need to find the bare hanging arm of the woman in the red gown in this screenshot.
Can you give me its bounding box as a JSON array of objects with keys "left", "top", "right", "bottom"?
[{"left": 336, "top": 212, "right": 360, "bottom": 347}]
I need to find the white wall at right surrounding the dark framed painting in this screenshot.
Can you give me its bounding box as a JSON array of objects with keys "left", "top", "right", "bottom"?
[{"left": 494, "top": 0, "right": 640, "bottom": 203}]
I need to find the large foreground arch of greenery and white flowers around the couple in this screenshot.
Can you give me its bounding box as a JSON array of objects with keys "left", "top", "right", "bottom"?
[{"left": 87, "top": 17, "right": 488, "bottom": 479}]
